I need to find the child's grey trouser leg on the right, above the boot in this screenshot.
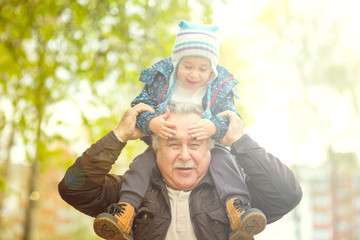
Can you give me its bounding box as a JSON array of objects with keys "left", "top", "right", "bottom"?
[{"left": 209, "top": 145, "right": 250, "bottom": 203}]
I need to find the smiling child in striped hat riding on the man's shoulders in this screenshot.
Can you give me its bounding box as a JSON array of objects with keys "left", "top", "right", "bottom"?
[{"left": 94, "top": 20, "right": 266, "bottom": 239}]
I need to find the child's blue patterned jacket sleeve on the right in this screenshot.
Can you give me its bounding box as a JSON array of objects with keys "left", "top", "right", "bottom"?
[{"left": 210, "top": 91, "right": 240, "bottom": 139}]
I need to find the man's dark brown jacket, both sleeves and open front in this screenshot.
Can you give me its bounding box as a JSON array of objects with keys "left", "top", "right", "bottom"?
[{"left": 59, "top": 132, "right": 302, "bottom": 240}]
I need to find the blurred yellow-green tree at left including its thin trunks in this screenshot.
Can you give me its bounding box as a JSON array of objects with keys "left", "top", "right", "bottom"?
[{"left": 0, "top": 0, "right": 219, "bottom": 239}]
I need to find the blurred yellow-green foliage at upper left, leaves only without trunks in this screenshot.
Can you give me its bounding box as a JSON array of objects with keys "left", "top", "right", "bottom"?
[{"left": 0, "top": 0, "right": 217, "bottom": 165}]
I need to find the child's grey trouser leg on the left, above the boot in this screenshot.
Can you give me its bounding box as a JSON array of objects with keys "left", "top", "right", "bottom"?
[{"left": 119, "top": 147, "right": 156, "bottom": 210}]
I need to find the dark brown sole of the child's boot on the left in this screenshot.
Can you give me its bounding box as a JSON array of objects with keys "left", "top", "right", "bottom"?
[{"left": 93, "top": 214, "right": 133, "bottom": 240}]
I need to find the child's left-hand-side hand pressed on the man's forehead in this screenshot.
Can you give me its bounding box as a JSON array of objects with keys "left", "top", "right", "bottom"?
[{"left": 149, "top": 109, "right": 176, "bottom": 139}]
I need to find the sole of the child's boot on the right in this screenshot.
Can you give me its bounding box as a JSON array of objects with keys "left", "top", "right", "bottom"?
[{"left": 229, "top": 212, "right": 266, "bottom": 240}]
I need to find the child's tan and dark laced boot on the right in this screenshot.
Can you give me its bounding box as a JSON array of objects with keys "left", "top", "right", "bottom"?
[{"left": 226, "top": 198, "right": 266, "bottom": 240}]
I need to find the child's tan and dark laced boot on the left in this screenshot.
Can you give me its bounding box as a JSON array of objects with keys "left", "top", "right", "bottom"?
[{"left": 94, "top": 202, "right": 135, "bottom": 240}]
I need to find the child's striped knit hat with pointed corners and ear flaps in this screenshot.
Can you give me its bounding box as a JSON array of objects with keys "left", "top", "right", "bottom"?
[{"left": 171, "top": 20, "right": 220, "bottom": 79}]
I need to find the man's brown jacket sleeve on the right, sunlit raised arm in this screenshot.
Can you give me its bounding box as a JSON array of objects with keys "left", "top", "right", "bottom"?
[{"left": 231, "top": 134, "right": 302, "bottom": 223}]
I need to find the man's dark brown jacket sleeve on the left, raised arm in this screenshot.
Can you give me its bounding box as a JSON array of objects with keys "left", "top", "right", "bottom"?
[{"left": 58, "top": 131, "right": 125, "bottom": 217}]
